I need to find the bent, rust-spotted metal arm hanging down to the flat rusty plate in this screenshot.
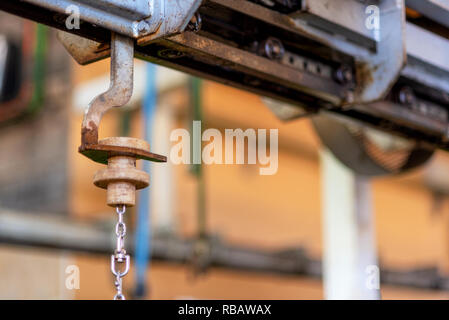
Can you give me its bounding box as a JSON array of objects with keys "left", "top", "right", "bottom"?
[{"left": 81, "top": 33, "right": 134, "bottom": 147}]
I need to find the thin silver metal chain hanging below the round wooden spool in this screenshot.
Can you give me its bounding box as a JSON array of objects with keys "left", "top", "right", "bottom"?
[{"left": 111, "top": 205, "right": 130, "bottom": 300}]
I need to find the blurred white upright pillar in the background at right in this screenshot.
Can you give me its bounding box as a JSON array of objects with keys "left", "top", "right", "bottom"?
[{"left": 321, "top": 149, "right": 380, "bottom": 300}]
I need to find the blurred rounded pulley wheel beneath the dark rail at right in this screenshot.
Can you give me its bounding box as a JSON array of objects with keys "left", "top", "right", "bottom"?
[{"left": 312, "top": 115, "right": 434, "bottom": 176}]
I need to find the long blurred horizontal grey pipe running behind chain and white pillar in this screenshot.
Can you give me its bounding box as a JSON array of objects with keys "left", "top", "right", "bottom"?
[{"left": 0, "top": 209, "right": 449, "bottom": 291}]
